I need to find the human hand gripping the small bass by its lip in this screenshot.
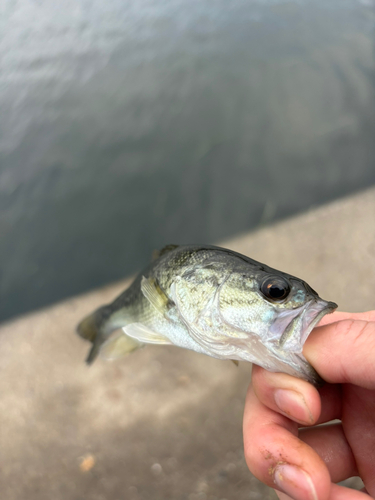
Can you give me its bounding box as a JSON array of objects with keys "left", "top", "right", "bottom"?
[{"left": 243, "top": 311, "right": 375, "bottom": 500}]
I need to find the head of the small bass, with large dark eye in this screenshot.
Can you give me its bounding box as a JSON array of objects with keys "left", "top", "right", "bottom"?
[{"left": 219, "top": 266, "right": 337, "bottom": 380}]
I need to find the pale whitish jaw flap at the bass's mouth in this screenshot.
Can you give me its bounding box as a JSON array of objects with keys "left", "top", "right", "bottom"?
[{"left": 279, "top": 299, "right": 338, "bottom": 353}]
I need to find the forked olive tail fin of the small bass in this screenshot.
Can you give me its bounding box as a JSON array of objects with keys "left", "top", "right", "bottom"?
[{"left": 77, "top": 306, "right": 112, "bottom": 365}]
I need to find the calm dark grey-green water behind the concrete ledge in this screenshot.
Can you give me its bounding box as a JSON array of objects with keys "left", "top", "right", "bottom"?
[{"left": 0, "top": 0, "right": 375, "bottom": 319}]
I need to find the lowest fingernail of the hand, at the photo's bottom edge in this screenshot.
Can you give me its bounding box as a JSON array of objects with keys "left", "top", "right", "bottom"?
[{"left": 273, "top": 464, "right": 318, "bottom": 500}]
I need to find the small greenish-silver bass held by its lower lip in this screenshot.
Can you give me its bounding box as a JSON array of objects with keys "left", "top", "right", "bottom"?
[{"left": 77, "top": 245, "right": 337, "bottom": 386}]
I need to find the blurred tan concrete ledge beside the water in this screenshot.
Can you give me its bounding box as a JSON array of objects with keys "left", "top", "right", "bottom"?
[{"left": 0, "top": 189, "right": 375, "bottom": 500}]
